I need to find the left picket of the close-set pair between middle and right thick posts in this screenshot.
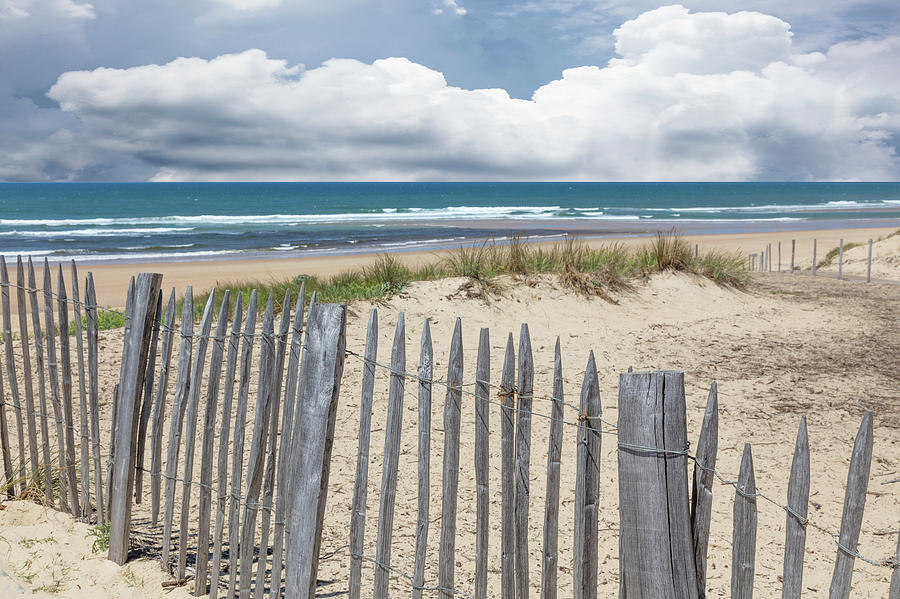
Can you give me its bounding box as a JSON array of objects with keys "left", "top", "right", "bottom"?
[{"left": 499, "top": 333, "right": 516, "bottom": 599}]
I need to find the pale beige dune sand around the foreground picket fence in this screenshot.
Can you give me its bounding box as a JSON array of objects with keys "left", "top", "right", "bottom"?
[{"left": 0, "top": 231, "right": 900, "bottom": 598}]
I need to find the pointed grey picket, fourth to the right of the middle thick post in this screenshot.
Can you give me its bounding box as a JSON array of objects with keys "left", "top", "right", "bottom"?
[{"left": 438, "top": 318, "right": 463, "bottom": 599}]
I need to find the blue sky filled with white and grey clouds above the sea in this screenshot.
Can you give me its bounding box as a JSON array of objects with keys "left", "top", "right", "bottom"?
[{"left": 0, "top": 0, "right": 900, "bottom": 181}]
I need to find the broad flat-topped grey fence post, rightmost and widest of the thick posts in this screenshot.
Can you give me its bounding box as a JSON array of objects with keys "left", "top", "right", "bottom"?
[{"left": 618, "top": 371, "right": 698, "bottom": 599}]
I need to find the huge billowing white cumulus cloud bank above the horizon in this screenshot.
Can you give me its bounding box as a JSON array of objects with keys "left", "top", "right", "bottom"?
[{"left": 31, "top": 6, "right": 900, "bottom": 180}]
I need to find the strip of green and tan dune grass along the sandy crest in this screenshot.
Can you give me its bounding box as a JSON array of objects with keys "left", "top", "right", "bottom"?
[{"left": 186, "top": 230, "right": 750, "bottom": 319}]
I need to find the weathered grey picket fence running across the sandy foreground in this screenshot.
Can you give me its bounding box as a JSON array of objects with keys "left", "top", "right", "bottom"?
[{"left": 0, "top": 260, "right": 900, "bottom": 599}]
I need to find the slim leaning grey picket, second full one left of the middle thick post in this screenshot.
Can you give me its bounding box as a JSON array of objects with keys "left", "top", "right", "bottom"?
[{"left": 254, "top": 290, "right": 291, "bottom": 598}]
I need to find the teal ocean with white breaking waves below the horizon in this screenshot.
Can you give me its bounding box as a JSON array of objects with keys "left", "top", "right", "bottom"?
[{"left": 0, "top": 183, "right": 900, "bottom": 262}]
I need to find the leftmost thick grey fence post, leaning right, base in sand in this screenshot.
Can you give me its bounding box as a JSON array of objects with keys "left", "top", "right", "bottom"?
[{"left": 108, "top": 273, "right": 162, "bottom": 565}]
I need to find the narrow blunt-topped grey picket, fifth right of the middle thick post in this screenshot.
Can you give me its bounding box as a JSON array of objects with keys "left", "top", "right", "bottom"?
[{"left": 475, "top": 328, "right": 491, "bottom": 599}]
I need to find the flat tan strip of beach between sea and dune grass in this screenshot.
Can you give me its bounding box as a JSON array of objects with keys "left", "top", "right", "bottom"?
[{"left": 7, "top": 225, "right": 897, "bottom": 311}]
